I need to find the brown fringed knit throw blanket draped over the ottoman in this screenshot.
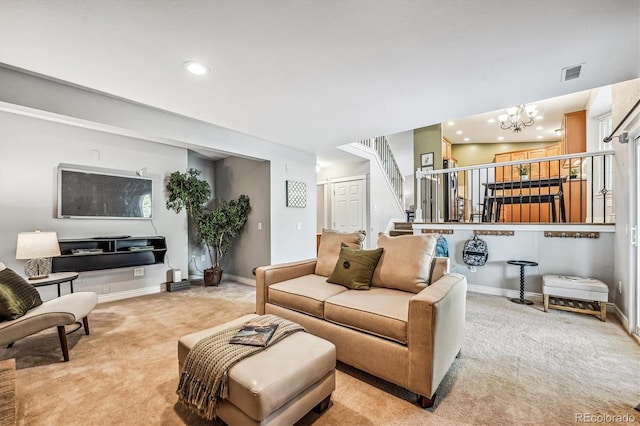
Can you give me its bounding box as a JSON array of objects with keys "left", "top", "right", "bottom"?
[{"left": 177, "top": 315, "right": 305, "bottom": 420}]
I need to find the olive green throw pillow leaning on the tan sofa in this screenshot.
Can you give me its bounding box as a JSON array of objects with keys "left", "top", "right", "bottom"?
[{"left": 327, "top": 243, "right": 383, "bottom": 290}]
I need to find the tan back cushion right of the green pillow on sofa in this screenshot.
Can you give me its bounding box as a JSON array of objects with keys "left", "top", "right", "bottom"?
[{"left": 372, "top": 234, "right": 436, "bottom": 293}]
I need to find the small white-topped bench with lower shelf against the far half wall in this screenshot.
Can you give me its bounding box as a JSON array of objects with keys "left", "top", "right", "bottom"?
[{"left": 542, "top": 275, "right": 609, "bottom": 321}]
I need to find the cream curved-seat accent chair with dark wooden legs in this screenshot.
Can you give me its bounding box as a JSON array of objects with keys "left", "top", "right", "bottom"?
[{"left": 0, "top": 262, "right": 98, "bottom": 361}]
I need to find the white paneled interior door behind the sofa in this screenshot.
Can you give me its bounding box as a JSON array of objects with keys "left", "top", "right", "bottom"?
[{"left": 331, "top": 179, "right": 366, "bottom": 232}]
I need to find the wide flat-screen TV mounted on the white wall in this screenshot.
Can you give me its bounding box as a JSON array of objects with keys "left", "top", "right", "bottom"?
[{"left": 58, "top": 164, "right": 153, "bottom": 219}]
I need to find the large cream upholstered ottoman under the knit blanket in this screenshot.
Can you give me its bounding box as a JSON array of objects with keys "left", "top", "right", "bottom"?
[{"left": 178, "top": 314, "right": 336, "bottom": 425}]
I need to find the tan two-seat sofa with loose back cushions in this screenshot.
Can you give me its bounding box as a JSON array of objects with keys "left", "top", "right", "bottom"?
[{"left": 256, "top": 231, "right": 467, "bottom": 407}]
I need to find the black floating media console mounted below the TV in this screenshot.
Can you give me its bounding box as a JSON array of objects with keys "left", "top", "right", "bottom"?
[{"left": 51, "top": 236, "right": 167, "bottom": 272}]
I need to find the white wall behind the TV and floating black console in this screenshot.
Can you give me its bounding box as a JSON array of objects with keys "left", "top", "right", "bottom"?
[{"left": 0, "top": 112, "right": 187, "bottom": 299}]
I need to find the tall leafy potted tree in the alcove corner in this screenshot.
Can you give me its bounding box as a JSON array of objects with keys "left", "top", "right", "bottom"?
[{"left": 166, "top": 168, "right": 251, "bottom": 286}]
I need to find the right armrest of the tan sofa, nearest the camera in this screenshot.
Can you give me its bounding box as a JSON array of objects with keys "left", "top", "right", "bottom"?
[{"left": 407, "top": 273, "right": 467, "bottom": 398}]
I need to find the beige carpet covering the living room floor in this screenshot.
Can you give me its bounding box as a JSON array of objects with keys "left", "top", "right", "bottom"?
[{"left": 0, "top": 283, "right": 640, "bottom": 425}]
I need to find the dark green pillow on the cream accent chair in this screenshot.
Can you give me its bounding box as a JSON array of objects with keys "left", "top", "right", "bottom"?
[{"left": 0, "top": 268, "right": 42, "bottom": 321}]
